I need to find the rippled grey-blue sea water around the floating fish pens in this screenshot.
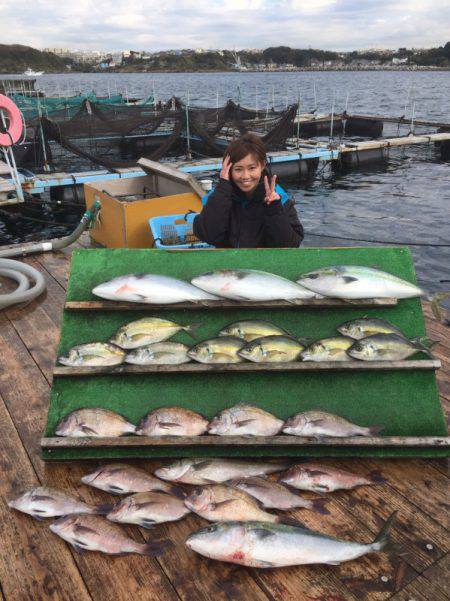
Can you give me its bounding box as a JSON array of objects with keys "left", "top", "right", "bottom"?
[{"left": 0, "top": 71, "right": 450, "bottom": 291}]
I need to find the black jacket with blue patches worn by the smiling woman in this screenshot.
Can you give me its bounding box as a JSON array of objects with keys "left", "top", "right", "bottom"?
[{"left": 194, "top": 179, "right": 303, "bottom": 248}]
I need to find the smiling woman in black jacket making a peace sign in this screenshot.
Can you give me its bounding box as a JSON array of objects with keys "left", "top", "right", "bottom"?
[{"left": 194, "top": 134, "right": 303, "bottom": 248}]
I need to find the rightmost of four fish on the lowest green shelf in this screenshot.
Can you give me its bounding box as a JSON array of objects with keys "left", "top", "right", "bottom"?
[{"left": 283, "top": 411, "right": 383, "bottom": 437}]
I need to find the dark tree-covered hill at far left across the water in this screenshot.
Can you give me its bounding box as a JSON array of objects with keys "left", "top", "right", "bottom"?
[{"left": 0, "top": 44, "right": 68, "bottom": 73}]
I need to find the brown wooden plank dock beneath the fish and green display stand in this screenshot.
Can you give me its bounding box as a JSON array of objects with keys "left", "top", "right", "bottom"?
[{"left": 0, "top": 238, "right": 450, "bottom": 601}]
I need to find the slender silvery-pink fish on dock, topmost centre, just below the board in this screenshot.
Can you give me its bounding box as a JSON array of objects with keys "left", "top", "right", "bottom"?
[{"left": 155, "top": 458, "right": 290, "bottom": 484}]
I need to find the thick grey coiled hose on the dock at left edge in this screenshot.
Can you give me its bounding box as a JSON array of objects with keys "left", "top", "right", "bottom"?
[{"left": 0, "top": 201, "right": 100, "bottom": 310}]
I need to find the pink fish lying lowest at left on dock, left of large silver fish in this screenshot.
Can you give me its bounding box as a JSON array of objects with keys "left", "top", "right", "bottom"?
[{"left": 49, "top": 515, "right": 170, "bottom": 557}]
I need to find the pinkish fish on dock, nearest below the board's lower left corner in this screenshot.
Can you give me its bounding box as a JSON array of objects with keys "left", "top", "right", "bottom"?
[{"left": 81, "top": 463, "right": 173, "bottom": 495}]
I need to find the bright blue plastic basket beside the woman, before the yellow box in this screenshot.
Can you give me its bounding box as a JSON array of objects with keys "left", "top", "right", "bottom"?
[{"left": 148, "top": 213, "right": 212, "bottom": 248}]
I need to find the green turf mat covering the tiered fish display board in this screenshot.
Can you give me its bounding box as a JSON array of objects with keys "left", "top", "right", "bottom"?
[{"left": 43, "top": 247, "right": 447, "bottom": 460}]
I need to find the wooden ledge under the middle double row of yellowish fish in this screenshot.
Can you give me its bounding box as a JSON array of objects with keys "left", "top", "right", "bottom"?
[{"left": 53, "top": 359, "right": 441, "bottom": 377}]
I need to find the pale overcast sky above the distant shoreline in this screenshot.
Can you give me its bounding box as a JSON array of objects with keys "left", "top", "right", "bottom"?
[{"left": 0, "top": 0, "right": 450, "bottom": 51}]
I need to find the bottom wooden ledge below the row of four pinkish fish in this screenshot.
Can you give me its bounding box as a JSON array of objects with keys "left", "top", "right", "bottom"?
[{"left": 41, "top": 435, "right": 450, "bottom": 449}]
